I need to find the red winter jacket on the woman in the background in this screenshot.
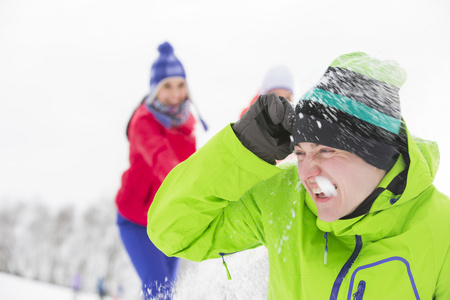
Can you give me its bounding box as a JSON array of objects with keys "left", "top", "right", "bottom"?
[{"left": 116, "top": 104, "right": 196, "bottom": 226}]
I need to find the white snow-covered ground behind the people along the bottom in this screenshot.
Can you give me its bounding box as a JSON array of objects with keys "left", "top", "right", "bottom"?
[{"left": 0, "top": 247, "right": 269, "bottom": 300}]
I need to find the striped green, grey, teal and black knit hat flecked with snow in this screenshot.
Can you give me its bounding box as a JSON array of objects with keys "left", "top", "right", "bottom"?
[{"left": 293, "top": 52, "right": 406, "bottom": 170}]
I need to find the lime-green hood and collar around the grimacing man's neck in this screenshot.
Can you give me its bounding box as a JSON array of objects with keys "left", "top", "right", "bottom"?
[{"left": 312, "top": 120, "right": 439, "bottom": 239}]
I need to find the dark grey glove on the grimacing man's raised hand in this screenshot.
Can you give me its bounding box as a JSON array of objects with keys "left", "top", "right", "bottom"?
[{"left": 232, "top": 93, "right": 294, "bottom": 164}]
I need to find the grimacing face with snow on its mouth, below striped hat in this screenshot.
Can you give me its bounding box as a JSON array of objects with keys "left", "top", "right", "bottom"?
[{"left": 294, "top": 143, "right": 386, "bottom": 222}]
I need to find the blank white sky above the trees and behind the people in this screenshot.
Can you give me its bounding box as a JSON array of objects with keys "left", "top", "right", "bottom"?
[{"left": 0, "top": 0, "right": 450, "bottom": 210}]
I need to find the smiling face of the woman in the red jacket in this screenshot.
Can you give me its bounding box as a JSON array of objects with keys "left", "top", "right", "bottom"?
[{"left": 156, "top": 77, "right": 188, "bottom": 107}]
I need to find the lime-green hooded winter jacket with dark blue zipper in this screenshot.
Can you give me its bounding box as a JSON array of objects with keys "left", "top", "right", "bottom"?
[{"left": 147, "top": 126, "right": 450, "bottom": 300}]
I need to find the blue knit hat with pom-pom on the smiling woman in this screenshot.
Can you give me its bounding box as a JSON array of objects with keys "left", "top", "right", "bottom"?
[{"left": 150, "top": 42, "right": 186, "bottom": 94}]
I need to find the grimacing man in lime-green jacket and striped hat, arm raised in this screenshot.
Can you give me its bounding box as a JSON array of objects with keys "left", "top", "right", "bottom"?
[{"left": 147, "top": 52, "right": 450, "bottom": 300}]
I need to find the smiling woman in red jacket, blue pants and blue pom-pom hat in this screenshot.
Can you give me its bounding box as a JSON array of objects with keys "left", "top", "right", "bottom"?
[{"left": 116, "top": 42, "right": 200, "bottom": 299}]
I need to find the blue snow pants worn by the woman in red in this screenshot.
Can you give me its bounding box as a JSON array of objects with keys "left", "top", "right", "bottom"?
[{"left": 117, "top": 213, "right": 179, "bottom": 299}]
